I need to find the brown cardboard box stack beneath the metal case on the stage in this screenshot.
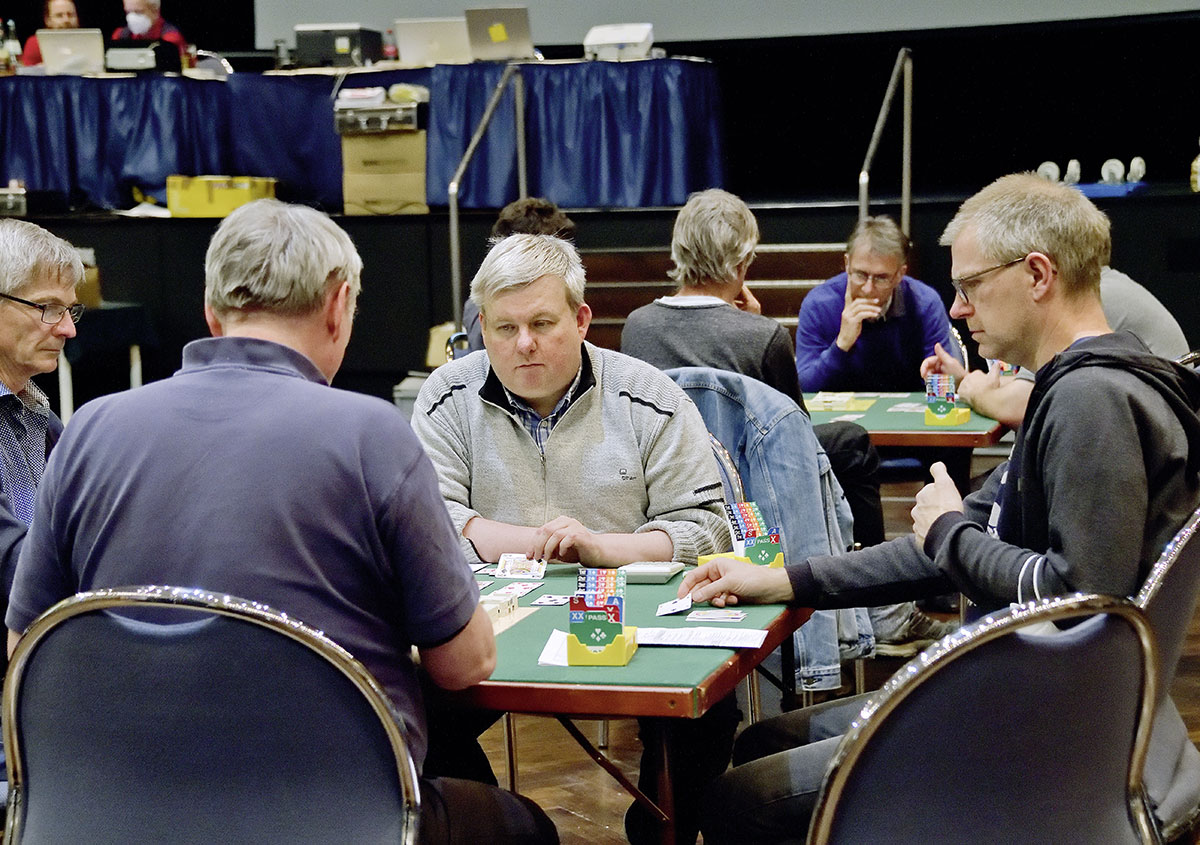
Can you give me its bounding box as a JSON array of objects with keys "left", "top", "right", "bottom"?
[{"left": 342, "top": 130, "right": 430, "bottom": 215}]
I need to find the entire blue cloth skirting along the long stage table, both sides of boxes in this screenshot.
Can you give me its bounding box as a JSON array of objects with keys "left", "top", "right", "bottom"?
[{"left": 0, "top": 59, "right": 724, "bottom": 211}]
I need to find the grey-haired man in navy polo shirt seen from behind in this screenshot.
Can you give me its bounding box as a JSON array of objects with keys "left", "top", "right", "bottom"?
[{"left": 6, "top": 199, "right": 558, "bottom": 845}]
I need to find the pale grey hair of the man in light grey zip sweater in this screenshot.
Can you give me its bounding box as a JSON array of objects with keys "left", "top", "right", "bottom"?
[{"left": 470, "top": 234, "right": 586, "bottom": 313}]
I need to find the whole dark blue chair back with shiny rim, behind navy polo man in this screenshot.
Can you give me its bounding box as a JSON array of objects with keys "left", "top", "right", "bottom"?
[{"left": 4, "top": 587, "right": 420, "bottom": 845}]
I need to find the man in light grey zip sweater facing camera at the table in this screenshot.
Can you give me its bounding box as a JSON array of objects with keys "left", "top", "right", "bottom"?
[{"left": 413, "top": 234, "right": 740, "bottom": 843}]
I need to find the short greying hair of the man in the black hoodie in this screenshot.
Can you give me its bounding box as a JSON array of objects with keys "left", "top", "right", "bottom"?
[{"left": 938, "top": 173, "right": 1112, "bottom": 294}]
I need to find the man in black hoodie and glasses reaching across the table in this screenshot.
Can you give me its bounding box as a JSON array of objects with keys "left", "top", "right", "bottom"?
[{"left": 679, "top": 174, "right": 1200, "bottom": 843}]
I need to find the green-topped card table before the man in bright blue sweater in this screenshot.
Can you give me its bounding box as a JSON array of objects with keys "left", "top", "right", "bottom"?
[{"left": 804, "top": 392, "right": 1004, "bottom": 448}]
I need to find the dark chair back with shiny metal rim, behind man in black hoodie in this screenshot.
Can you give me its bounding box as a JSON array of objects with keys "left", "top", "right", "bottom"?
[{"left": 808, "top": 595, "right": 1158, "bottom": 845}]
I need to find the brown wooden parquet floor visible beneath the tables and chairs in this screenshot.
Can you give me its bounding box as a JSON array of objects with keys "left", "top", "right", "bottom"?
[{"left": 482, "top": 458, "right": 1200, "bottom": 845}]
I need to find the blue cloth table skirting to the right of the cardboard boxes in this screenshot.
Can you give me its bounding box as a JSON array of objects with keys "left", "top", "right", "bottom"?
[{"left": 425, "top": 59, "right": 725, "bottom": 208}]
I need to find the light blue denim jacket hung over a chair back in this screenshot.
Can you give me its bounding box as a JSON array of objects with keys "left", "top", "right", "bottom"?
[{"left": 666, "top": 367, "right": 875, "bottom": 690}]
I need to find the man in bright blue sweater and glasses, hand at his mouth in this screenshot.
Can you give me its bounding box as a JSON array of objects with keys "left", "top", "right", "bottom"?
[{"left": 796, "top": 216, "right": 950, "bottom": 391}]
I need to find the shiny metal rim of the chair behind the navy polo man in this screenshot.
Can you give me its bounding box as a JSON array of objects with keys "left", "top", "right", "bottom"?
[{"left": 2, "top": 586, "right": 420, "bottom": 845}]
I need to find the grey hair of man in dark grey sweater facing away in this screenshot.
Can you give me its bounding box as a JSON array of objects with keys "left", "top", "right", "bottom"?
[{"left": 667, "top": 188, "right": 758, "bottom": 287}]
